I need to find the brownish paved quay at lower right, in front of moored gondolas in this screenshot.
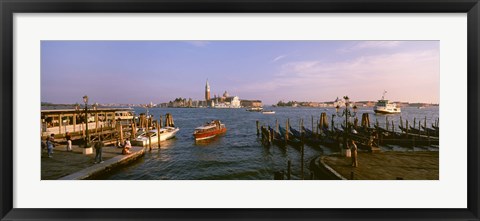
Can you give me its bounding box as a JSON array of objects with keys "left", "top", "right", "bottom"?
[{"left": 312, "top": 151, "right": 439, "bottom": 180}]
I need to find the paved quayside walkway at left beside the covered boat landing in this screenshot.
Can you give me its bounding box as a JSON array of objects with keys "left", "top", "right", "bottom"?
[{"left": 41, "top": 145, "right": 145, "bottom": 180}]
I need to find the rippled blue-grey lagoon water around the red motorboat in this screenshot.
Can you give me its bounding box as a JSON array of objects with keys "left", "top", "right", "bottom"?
[{"left": 100, "top": 107, "right": 439, "bottom": 180}]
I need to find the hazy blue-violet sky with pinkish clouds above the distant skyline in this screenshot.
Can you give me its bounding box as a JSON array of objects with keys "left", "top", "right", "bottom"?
[{"left": 41, "top": 41, "right": 440, "bottom": 104}]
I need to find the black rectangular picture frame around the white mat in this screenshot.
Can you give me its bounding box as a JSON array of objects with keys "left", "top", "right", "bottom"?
[{"left": 0, "top": 0, "right": 480, "bottom": 220}]
